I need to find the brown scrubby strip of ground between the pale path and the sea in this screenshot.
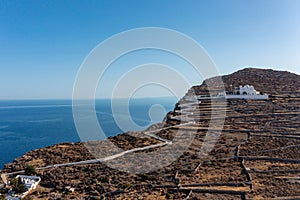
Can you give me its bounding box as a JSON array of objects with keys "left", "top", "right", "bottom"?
[{"left": 4, "top": 132, "right": 160, "bottom": 172}]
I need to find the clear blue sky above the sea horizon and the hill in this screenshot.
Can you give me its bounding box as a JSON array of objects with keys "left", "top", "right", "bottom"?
[{"left": 0, "top": 0, "right": 300, "bottom": 99}]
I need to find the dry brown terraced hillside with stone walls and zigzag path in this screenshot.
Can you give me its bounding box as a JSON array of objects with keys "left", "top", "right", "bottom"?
[{"left": 1, "top": 68, "right": 300, "bottom": 200}]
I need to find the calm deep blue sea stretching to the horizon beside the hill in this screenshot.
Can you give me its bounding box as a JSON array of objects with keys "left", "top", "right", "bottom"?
[{"left": 0, "top": 97, "right": 177, "bottom": 168}]
